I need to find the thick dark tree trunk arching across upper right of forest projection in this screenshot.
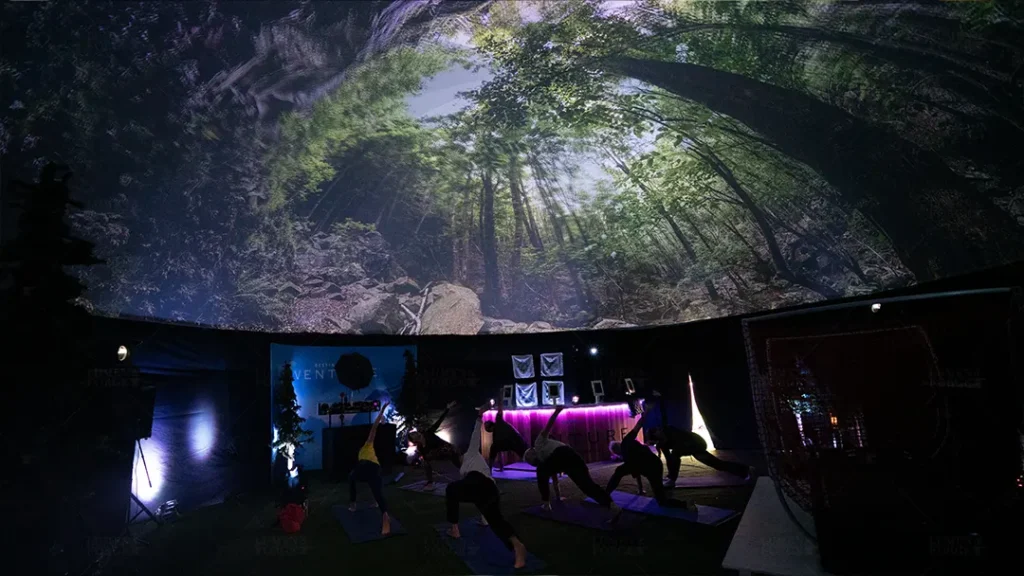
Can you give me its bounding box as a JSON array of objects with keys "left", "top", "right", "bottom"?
[{"left": 604, "top": 56, "right": 1024, "bottom": 281}]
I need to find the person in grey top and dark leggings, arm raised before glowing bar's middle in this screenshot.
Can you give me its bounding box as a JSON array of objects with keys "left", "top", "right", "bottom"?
[{"left": 523, "top": 406, "right": 623, "bottom": 522}]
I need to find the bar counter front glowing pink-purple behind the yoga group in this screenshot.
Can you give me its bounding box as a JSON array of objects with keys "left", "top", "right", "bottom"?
[{"left": 481, "top": 403, "right": 643, "bottom": 464}]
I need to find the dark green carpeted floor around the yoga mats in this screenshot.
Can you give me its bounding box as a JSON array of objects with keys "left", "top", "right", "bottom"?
[{"left": 101, "top": 464, "right": 753, "bottom": 576}]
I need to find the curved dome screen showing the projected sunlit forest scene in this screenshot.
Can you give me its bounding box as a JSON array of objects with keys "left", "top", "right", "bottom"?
[{"left": 0, "top": 0, "right": 1024, "bottom": 334}]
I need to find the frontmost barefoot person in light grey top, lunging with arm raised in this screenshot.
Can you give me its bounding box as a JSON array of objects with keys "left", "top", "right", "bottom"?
[{"left": 444, "top": 406, "right": 526, "bottom": 568}]
